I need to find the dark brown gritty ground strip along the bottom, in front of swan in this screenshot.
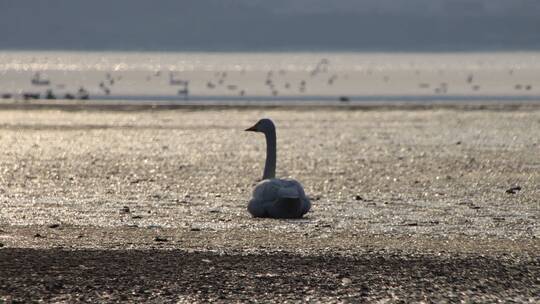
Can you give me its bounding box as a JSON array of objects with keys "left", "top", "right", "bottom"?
[{"left": 0, "top": 249, "right": 540, "bottom": 303}]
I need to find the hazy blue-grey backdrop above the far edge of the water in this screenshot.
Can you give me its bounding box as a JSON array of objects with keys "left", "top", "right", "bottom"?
[{"left": 0, "top": 0, "right": 540, "bottom": 51}]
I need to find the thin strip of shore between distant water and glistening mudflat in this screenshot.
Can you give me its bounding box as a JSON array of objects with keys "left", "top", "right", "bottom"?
[{"left": 0, "top": 96, "right": 540, "bottom": 111}]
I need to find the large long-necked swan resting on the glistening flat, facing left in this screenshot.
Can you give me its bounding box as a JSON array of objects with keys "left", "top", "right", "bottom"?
[{"left": 246, "top": 119, "right": 311, "bottom": 218}]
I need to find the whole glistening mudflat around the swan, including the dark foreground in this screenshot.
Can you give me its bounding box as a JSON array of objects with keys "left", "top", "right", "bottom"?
[{"left": 0, "top": 105, "right": 540, "bottom": 302}]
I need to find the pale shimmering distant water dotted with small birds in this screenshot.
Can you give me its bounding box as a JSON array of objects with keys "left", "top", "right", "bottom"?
[{"left": 0, "top": 51, "right": 540, "bottom": 104}]
